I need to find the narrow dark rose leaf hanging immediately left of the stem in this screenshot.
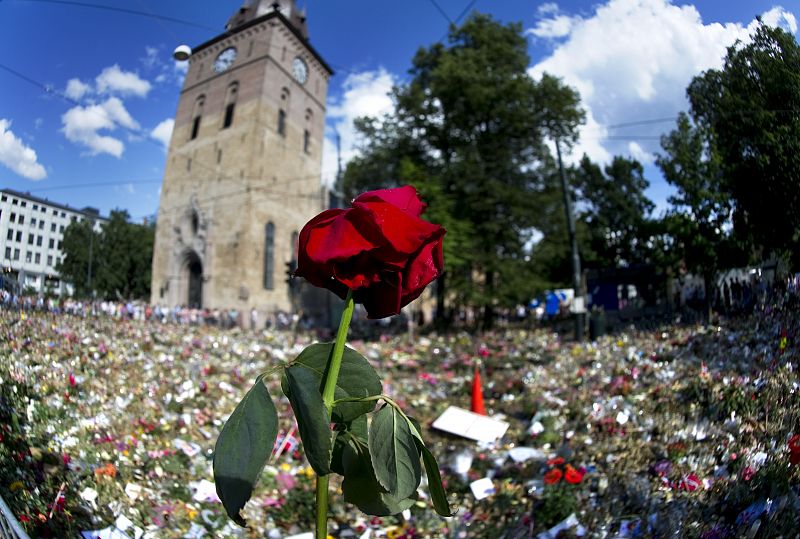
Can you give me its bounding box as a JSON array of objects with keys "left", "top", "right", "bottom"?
[{"left": 281, "top": 365, "right": 333, "bottom": 475}]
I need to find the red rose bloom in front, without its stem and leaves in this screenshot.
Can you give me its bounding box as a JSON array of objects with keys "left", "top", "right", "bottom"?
[{"left": 295, "top": 186, "right": 445, "bottom": 318}]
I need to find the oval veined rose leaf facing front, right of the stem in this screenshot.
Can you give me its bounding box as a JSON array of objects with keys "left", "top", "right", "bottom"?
[{"left": 369, "top": 405, "right": 421, "bottom": 499}]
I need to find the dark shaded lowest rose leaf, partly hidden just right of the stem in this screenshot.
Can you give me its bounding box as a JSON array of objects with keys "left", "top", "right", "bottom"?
[{"left": 342, "top": 437, "right": 416, "bottom": 517}]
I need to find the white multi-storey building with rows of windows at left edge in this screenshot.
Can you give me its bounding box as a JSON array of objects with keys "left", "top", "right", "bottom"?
[{"left": 0, "top": 189, "right": 107, "bottom": 295}]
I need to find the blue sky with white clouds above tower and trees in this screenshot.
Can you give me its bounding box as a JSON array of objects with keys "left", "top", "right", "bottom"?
[{"left": 0, "top": 0, "right": 800, "bottom": 219}]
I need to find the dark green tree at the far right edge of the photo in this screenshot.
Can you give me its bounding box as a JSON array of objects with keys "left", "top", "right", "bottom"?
[{"left": 687, "top": 24, "right": 800, "bottom": 264}]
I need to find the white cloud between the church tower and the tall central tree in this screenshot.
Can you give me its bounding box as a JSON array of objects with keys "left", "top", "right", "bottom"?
[{"left": 322, "top": 68, "right": 397, "bottom": 185}]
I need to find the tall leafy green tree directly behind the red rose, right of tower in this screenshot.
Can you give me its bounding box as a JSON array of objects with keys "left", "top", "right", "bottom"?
[{"left": 344, "top": 15, "right": 583, "bottom": 327}]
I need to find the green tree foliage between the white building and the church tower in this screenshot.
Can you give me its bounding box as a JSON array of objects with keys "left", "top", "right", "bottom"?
[{"left": 56, "top": 210, "right": 155, "bottom": 299}]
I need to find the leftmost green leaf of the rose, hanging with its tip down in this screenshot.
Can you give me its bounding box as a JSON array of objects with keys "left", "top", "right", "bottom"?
[{"left": 214, "top": 377, "right": 278, "bottom": 526}]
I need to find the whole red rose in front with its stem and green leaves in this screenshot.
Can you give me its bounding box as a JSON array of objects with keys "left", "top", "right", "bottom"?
[{"left": 209, "top": 186, "right": 452, "bottom": 538}]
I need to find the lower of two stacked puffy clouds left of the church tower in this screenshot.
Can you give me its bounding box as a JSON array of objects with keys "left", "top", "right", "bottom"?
[{"left": 61, "top": 97, "right": 139, "bottom": 157}]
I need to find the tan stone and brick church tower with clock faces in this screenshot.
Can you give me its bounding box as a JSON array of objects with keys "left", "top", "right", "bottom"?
[{"left": 151, "top": 0, "right": 333, "bottom": 322}]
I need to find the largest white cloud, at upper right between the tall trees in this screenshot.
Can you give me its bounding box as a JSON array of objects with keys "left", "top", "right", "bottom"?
[{"left": 528, "top": 0, "right": 797, "bottom": 162}]
